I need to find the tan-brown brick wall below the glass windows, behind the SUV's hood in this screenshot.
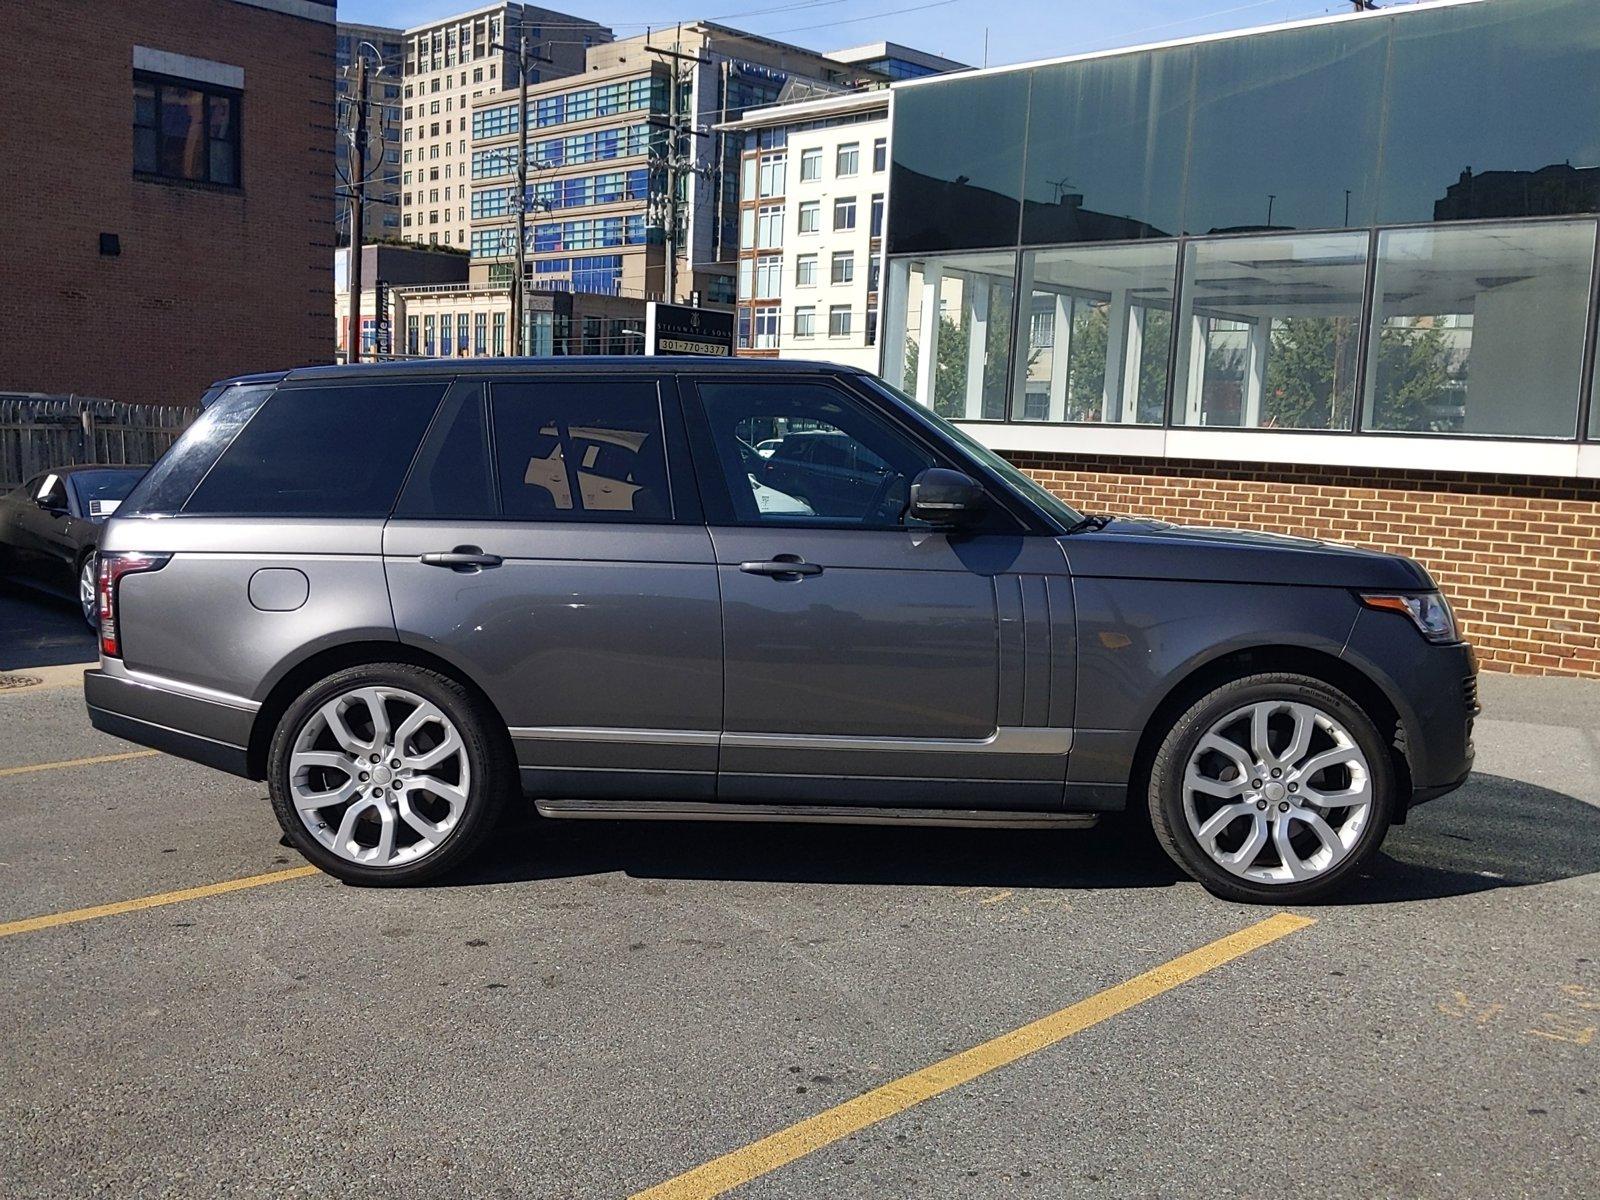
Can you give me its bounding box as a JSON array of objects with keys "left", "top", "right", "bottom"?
[{"left": 1008, "top": 453, "right": 1600, "bottom": 677}]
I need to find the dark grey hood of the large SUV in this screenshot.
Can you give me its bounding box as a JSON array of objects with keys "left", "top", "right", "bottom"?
[{"left": 1061, "top": 517, "right": 1434, "bottom": 592}]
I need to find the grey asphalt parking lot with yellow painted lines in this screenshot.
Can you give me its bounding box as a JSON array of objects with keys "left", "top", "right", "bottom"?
[{"left": 0, "top": 579, "right": 1600, "bottom": 1198}]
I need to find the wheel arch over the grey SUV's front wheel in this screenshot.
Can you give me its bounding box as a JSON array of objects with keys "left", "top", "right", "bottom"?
[{"left": 1128, "top": 645, "right": 1411, "bottom": 824}]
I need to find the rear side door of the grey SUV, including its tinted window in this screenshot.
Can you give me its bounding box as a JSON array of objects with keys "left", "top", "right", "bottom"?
[{"left": 384, "top": 373, "right": 722, "bottom": 800}]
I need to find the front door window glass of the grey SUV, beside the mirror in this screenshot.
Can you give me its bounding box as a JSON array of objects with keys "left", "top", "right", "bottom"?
[{"left": 699, "top": 379, "right": 936, "bottom": 528}]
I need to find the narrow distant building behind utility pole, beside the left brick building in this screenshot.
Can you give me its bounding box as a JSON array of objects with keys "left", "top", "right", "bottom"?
[{"left": 333, "top": 21, "right": 405, "bottom": 246}]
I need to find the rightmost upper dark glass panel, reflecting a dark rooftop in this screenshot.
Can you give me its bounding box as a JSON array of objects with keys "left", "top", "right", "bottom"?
[{"left": 1378, "top": 0, "right": 1600, "bottom": 224}]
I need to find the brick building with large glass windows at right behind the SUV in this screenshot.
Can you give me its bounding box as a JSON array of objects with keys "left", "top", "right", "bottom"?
[{"left": 878, "top": 0, "right": 1600, "bottom": 677}]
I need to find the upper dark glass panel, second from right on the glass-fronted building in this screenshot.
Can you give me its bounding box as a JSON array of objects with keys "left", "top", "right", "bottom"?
[{"left": 1184, "top": 18, "right": 1382, "bottom": 234}]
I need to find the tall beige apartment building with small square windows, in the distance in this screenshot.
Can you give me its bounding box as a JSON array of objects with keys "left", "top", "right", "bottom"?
[{"left": 400, "top": 3, "right": 611, "bottom": 246}]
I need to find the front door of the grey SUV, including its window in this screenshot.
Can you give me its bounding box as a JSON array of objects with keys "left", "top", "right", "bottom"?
[{"left": 690, "top": 374, "right": 1070, "bottom": 811}]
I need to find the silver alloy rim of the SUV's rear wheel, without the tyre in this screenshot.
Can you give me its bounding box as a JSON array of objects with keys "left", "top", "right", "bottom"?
[{"left": 290, "top": 686, "right": 472, "bottom": 867}]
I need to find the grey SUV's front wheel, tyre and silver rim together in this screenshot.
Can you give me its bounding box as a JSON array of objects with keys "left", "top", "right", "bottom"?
[{"left": 1149, "top": 674, "right": 1395, "bottom": 904}]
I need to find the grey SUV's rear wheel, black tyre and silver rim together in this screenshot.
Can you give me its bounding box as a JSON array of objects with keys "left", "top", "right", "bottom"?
[{"left": 267, "top": 662, "right": 517, "bottom": 885}]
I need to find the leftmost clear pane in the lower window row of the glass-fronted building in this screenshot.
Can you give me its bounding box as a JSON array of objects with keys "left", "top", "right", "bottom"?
[{"left": 885, "top": 251, "right": 1016, "bottom": 421}]
